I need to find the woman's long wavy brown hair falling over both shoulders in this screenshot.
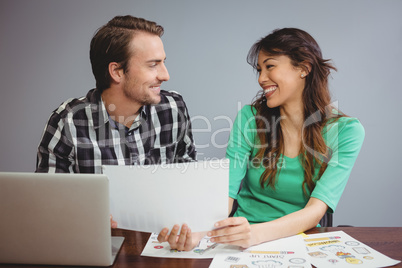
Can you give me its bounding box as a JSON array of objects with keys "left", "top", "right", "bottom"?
[{"left": 247, "top": 28, "right": 342, "bottom": 196}]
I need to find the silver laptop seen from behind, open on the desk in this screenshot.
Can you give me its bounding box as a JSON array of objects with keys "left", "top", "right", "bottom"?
[{"left": 0, "top": 172, "right": 124, "bottom": 266}]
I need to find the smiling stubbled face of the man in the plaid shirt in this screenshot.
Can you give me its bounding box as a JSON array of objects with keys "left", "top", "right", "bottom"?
[{"left": 123, "top": 32, "right": 169, "bottom": 106}]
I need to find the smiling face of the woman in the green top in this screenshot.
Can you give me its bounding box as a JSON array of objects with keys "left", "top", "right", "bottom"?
[{"left": 257, "top": 51, "right": 306, "bottom": 109}]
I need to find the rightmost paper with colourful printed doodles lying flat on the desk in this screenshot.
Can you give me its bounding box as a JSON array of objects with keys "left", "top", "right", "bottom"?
[{"left": 303, "top": 231, "right": 400, "bottom": 268}]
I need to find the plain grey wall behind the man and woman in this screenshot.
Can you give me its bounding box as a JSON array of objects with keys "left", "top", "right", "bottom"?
[{"left": 0, "top": 0, "right": 402, "bottom": 226}]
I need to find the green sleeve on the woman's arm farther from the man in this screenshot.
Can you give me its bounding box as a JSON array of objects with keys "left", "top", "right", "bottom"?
[{"left": 311, "top": 117, "right": 365, "bottom": 213}]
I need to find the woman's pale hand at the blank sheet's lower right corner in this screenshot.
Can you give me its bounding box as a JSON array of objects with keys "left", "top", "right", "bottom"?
[{"left": 207, "top": 217, "right": 258, "bottom": 248}]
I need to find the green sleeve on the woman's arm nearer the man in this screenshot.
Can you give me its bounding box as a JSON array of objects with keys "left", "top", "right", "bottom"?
[{"left": 226, "top": 105, "right": 256, "bottom": 199}]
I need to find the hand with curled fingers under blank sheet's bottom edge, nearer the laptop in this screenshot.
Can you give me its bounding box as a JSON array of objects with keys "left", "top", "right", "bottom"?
[{"left": 158, "top": 224, "right": 202, "bottom": 251}]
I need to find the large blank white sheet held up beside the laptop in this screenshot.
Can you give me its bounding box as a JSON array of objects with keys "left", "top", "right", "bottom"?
[{"left": 103, "top": 159, "right": 229, "bottom": 233}]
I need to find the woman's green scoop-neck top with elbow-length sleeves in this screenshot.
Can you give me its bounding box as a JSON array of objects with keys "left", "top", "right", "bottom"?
[{"left": 226, "top": 105, "right": 365, "bottom": 224}]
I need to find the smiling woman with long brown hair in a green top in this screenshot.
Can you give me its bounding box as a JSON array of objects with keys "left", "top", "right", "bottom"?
[{"left": 160, "top": 28, "right": 364, "bottom": 250}]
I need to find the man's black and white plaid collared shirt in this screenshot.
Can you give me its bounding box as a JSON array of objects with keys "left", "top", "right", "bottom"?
[{"left": 36, "top": 89, "right": 196, "bottom": 173}]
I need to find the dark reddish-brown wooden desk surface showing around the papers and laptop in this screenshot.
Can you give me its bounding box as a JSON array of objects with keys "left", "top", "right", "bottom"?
[{"left": 0, "top": 227, "right": 402, "bottom": 268}]
